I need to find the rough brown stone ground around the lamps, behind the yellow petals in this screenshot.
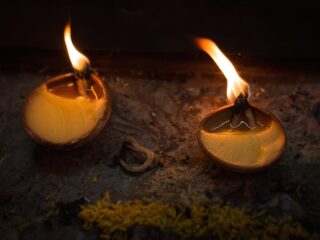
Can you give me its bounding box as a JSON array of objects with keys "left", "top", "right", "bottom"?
[{"left": 0, "top": 55, "right": 320, "bottom": 239}]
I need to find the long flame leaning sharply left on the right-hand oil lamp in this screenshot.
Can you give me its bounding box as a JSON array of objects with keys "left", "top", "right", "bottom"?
[{"left": 196, "top": 38, "right": 250, "bottom": 103}]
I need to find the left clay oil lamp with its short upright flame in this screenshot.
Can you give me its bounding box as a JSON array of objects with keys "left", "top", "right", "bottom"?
[{"left": 23, "top": 24, "right": 111, "bottom": 147}]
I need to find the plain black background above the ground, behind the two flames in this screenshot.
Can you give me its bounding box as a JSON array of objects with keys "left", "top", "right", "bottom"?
[{"left": 0, "top": 0, "right": 320, "bottom": 59}]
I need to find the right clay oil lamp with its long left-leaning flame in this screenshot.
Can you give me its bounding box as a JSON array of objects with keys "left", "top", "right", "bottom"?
[{"left": 196, "top": 38, "right": 286, "bottom": 172}]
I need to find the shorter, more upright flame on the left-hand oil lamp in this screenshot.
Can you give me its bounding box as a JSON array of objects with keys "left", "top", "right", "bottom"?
[{"left": 64, "top": 23, "right": 90, "bottom": 72}]
